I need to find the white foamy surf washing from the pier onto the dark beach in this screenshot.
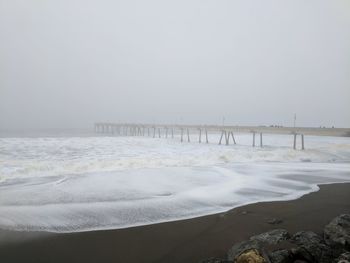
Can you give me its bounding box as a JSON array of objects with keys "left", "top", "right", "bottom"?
[{"left": 0, "top": 134, "right": 350, "bottom": 232}]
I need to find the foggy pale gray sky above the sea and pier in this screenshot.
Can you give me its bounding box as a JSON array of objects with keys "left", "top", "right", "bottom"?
[{"left": 0, "top": 0, "right": 350, "bottom": 129}]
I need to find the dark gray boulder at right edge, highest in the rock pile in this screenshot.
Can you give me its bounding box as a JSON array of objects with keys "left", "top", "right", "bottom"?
[{"left": 324, "top": 214, "right": 350, "bottom": 250}]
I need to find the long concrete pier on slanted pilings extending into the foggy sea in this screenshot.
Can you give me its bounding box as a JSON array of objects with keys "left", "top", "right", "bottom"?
[{"left": 94, "top": 122, "right": 350, "bottom": 150}]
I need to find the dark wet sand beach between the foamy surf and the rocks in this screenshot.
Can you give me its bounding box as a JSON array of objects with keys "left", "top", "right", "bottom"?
[{"left": 0, "top": 183, "right": 350, "bottom": 263}]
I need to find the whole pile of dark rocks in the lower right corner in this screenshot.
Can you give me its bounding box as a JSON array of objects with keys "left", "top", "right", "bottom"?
[{"left": 198, "top": 214, "right": 350, "bottom": 263}]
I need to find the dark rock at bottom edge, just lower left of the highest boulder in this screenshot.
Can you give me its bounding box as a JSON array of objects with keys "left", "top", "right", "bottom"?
[{"left": 290, "top": 231, "right": 334, "bottom": 262}]
